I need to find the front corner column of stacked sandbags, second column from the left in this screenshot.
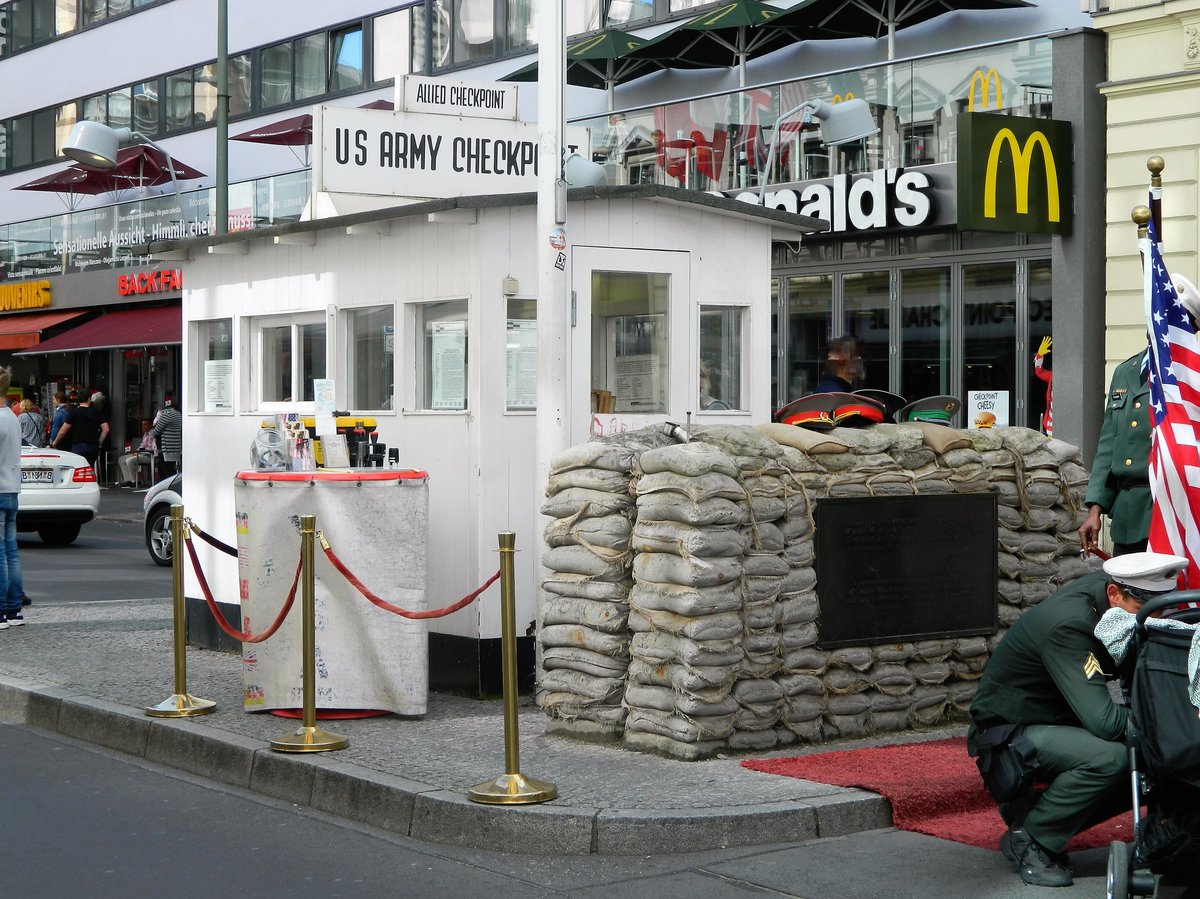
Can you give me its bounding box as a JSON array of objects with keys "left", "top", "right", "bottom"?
[{"left": 624, "top": 442, "right": 750, "bottom": 759}]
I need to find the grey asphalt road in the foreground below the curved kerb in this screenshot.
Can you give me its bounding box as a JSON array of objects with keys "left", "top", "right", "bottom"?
[{"left": 0, "top": 725, "right": 1123, "bottom": 899}]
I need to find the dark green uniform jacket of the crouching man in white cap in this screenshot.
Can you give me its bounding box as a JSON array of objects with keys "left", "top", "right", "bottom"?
[{"left": 967, "top": 571, "right": 1126, "bottom": 754}]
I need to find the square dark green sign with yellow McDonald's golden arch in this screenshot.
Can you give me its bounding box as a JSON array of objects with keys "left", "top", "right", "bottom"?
[{"left": 958, "top": 113, "right": 1073, "bottom": 234}]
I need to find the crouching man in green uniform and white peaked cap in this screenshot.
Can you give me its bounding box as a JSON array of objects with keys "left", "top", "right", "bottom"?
[{"left": 967, "top": 552, "right": 1188, "bottom": 887}]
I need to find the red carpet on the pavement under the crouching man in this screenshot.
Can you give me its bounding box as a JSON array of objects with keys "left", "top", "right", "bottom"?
[{"left": 742, "top": 738, "right": 1133, "bottom": 850}]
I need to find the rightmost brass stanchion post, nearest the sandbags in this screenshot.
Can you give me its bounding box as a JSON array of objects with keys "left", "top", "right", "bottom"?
[{"left": 467, "top": 531, "right": 558, "bottom": 805}]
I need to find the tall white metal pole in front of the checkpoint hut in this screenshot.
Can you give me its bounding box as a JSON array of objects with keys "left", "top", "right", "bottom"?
[{"left": 534, "top": 0, "right": 570, "bottom": 540}]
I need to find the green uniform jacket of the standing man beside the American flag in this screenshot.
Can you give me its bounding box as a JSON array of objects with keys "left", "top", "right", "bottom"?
[{"left": 1084, "top": 353, "right": 1153, "bottom": 544}]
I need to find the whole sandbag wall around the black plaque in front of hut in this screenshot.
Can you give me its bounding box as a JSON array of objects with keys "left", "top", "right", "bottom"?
[{"left": 538, "top": 424, "right": 1090, "bottom": 759}]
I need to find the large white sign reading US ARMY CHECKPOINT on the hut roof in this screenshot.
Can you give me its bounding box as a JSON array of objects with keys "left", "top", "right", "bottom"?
[{"left": 313, "top": 106, "right": 538, "bottom": 198}]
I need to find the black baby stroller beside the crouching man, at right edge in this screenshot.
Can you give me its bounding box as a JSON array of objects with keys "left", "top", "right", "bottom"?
[{"left": 1108, "top": 591, "right": 1200, "bottom": 899}]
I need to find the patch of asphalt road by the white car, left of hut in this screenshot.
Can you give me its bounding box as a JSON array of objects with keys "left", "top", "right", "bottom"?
[{"left": 17, "top": 490, "right": 170, "bottom": 606}]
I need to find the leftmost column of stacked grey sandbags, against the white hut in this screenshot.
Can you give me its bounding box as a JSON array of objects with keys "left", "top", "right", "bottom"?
[{"left": 538, "top": 427, "right": 671, "bottom": 738}]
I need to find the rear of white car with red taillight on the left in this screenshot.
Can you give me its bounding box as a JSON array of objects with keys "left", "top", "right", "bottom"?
[{"left": 17, "top": 446, "right": 100, "bottom": 546}]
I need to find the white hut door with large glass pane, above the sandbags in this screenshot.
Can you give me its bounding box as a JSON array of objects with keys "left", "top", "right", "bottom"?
[{"left": 570, "top": 247, "right": 696, "bottom": 442}]
